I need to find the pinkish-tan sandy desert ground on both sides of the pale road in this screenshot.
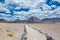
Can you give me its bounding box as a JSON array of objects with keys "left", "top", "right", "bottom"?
[{"left": 0, "top": 23, "right": 60, "bottom": 40}]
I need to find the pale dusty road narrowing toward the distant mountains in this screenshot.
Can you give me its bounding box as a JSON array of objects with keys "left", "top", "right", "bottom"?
[{"left": 25, "top": 25, "right": 46, "bottom": 40}]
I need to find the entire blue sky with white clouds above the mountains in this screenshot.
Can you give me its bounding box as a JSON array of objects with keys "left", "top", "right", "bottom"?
[{"left": 0, "top": 0, "right": 60, "bottom": 21}]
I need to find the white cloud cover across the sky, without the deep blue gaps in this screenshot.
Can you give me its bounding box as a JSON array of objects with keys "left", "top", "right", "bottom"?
[{"left": 0, "top": 0, "right": 60, "bottom": 21}]
